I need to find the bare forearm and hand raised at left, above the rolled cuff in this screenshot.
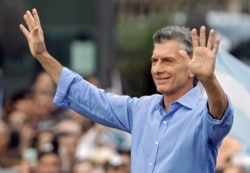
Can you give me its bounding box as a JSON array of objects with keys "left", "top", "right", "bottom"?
[{"left": 20, "top": 9, "right": 63, "bottom": 84}]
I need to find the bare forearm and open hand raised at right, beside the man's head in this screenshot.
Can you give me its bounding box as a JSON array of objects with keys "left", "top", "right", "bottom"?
[{"left": 181, "top": 26, "right": 228, "bottom": 119}]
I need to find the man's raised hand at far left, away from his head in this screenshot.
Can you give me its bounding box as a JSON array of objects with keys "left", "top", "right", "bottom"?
[{"left": 19, "top": 9, "right": 46, "bottom": 58}]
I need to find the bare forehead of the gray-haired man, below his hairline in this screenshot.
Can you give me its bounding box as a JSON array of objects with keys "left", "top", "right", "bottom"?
[{"left": 153, "top": 40, "right": 180, "bottom": 57}]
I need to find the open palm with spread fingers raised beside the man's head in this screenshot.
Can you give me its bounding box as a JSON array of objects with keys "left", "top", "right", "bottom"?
[{"left": 188, "top": 26, "right": 220, "bottom": 82}]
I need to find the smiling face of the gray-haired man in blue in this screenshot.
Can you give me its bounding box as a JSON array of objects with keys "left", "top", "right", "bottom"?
[{"left": 151, "top": 40, "right": 193, "bottom": 97}]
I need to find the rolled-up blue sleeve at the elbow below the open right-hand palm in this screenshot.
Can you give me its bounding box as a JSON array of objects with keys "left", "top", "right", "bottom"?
[{"left": 206, "top": 96, "right": 234, "bottom": 144}]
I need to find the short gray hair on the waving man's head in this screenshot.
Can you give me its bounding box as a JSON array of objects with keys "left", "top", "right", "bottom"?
[{"left": 153, "top": 26, "right": 198, "bottom": 86}]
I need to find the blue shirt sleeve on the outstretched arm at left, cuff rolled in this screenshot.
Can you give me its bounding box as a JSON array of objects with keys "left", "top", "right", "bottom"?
[{"left": 53, "top": 67, "right": 132, "bottom": 132}]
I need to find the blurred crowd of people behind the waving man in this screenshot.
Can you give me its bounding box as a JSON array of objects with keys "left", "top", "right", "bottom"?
[{"left": 0, "top": 72, "right": 250, "bottom": 173}]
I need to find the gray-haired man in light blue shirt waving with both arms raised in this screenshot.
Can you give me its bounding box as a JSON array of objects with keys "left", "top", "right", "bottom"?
[{"left": 20, "top": 9, "right": 233, "bottom": 173}]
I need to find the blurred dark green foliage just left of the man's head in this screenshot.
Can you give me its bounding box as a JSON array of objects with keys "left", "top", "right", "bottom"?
[{"left": 117, "top": 14, "right": 169, "bottom": 96}]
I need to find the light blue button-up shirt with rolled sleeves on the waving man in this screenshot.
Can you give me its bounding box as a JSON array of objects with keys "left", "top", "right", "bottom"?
[{"left": 54, "top": 67, "right": 233, "bottom": 173}]
